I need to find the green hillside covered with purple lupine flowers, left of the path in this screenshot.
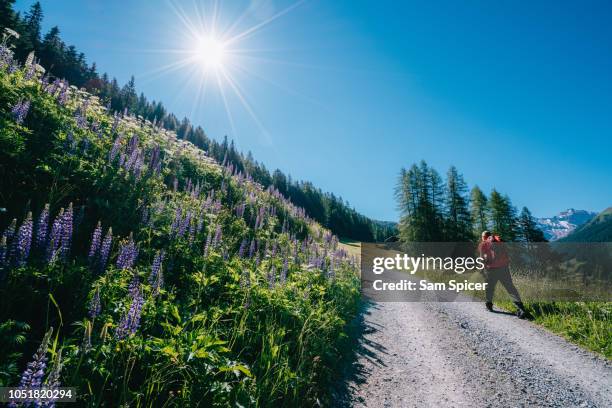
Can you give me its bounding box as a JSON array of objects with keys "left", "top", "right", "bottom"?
[{"left": 0, "top": 48, "right": 359, "bottom": 407}]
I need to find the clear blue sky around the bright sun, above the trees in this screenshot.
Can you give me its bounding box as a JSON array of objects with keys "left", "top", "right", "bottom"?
[{"left": 16, "top": 0, "right": 612, "bottom": 220}]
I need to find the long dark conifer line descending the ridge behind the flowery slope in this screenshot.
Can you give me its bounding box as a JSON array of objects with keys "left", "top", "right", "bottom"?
[{"left": 0, "top": 0, "right": 396, "bottom": 241}]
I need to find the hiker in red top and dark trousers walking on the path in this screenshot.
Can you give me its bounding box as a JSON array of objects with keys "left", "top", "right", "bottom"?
[{"left": 478, "top": 231, "right": 527, "bottom": 319}]
